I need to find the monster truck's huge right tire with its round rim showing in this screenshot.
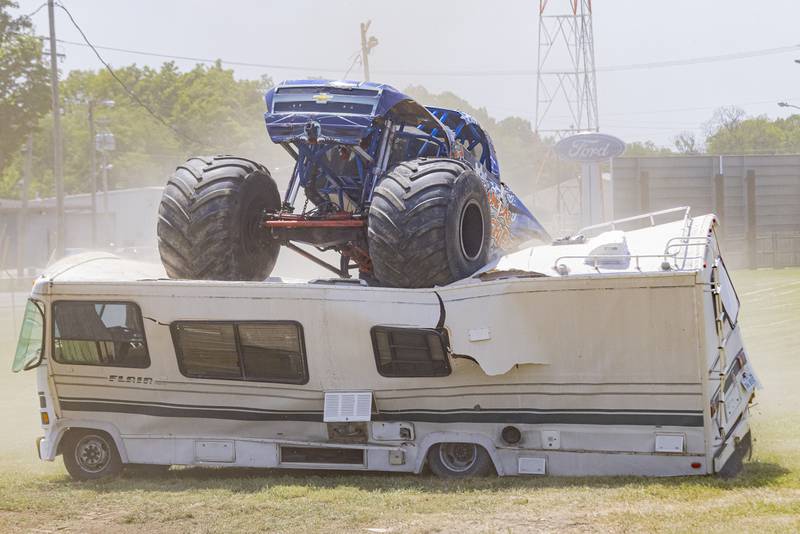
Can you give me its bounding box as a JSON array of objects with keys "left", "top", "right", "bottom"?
[{"left": 368, "top": 158, "right": 492, "bottom": 288}]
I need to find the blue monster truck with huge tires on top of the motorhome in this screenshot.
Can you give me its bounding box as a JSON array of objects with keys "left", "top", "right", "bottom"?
[{"left": 158, "top": 80, "right": 548, "bottom": 288}]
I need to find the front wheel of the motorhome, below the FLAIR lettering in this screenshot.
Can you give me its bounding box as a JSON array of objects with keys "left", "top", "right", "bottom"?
[{"left": 61, "top": 430, "right": 122, "bottom": 480}]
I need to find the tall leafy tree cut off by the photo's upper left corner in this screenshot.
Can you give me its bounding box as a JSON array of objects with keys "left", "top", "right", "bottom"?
[{"left": 0, "top": 0, "right": 50, "bottom": 173}]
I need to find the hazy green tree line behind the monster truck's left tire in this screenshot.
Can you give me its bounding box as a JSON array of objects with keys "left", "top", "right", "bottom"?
[{"left": 0, "top": 63, "right": 290, "bottom": 197}]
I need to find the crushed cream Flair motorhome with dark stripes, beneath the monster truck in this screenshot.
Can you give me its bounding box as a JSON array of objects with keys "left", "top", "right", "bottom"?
[{"left": 14, "top": 209, "right": 758, "bottom": 478}]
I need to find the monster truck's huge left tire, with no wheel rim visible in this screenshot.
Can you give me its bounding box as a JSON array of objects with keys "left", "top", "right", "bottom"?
[{"left": 158, "top": 156, "right": 281, "bottom": 280}]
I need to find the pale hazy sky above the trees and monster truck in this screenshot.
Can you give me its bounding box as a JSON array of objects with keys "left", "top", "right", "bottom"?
[{"left": 18, "top": 0, "right": 800, "bottom": 146}]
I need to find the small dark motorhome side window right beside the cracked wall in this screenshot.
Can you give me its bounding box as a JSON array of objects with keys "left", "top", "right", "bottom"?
[{"left": 371, "top": 326, "right": 450, "bottom": 377}]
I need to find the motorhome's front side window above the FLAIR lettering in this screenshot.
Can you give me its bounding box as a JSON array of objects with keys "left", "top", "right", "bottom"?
[{"left": 53, "top": 301, "right": 150, "bottom": 368}]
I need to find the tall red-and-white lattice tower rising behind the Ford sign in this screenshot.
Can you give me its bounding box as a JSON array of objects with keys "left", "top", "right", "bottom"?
[{"left": 536, "top": 0, "right": 599, "bottom": 139}]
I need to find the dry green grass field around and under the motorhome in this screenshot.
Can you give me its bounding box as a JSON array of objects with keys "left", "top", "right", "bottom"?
[{"left": 0, "top": 269, "right": 800, "bottom": 533}]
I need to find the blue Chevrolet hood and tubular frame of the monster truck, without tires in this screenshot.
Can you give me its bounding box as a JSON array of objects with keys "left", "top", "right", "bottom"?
[{"left": 265, "top": 80, "right": 499, "bottom": 215}]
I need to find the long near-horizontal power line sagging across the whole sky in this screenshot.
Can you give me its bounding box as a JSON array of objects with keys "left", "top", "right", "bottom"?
[{"left": 34, "top": 37, "right": 800, "bottom": 77}]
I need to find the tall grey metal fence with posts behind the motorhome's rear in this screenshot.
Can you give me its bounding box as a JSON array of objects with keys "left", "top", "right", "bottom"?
[{"left": 613, "top": 155, "right": 800, "bottom": 268}]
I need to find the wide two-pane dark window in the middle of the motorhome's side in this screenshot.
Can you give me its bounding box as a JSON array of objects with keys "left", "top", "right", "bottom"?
[{"left": 173, "top": 321, "right": 308, "bottom": 384}]
